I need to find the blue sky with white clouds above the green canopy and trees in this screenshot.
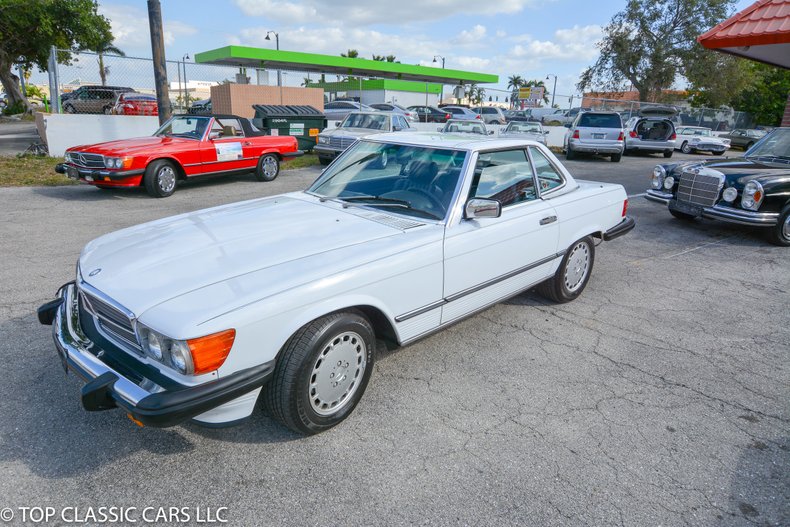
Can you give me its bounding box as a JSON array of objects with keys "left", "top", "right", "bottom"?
[{"left": 99, "top": 0, "right": 752, "bottom": 104}]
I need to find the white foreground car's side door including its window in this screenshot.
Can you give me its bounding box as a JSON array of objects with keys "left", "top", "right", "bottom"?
[{"left": 442, "top": 147, "right": 559, "bottom": 323}]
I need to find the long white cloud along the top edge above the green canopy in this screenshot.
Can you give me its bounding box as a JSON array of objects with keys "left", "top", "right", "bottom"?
[{"left": 235, "top": 0, "right": 543, "bottom": 27}]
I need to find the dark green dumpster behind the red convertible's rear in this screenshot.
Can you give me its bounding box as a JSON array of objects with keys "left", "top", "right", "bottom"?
[{"left": 252, "top": 104, "right": 326, "bottom": 152}]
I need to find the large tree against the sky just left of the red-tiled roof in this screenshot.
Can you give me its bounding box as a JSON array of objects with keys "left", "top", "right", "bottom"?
[{"left": 577, "top": 0, "right": 734, "bottom": 101}]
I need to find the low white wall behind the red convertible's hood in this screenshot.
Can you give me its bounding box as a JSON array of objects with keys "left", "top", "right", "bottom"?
[{"left": 42, "top": 114, "right": 159, "bottom": 157}]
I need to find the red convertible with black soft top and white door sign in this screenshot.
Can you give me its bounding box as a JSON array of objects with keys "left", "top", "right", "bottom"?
[{"left": 55, "top": 115, "right": 303, "bottom": 198}]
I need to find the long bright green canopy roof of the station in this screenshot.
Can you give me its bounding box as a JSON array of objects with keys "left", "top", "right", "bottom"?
[{"left": 195, "top": 46, "right": 499, "bottom": 84}]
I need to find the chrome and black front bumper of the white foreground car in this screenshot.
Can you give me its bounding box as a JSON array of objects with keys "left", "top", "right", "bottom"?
[{"left": 38, "top": 283, "right": 274, "bottom": 427}]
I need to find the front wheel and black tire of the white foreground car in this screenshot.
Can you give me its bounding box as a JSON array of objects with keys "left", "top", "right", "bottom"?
[{"left": 262, "top": 311, "right": 376, "bottom": 435}]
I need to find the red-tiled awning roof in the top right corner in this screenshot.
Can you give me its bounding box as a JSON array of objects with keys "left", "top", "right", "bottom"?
[{"left": 697, "top": 0, "right": 790, "bottom": 68}]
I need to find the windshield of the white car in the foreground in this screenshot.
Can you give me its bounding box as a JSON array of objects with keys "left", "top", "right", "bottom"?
[{"left": 307, "top": 141, "right": 466, "bottom": 220}]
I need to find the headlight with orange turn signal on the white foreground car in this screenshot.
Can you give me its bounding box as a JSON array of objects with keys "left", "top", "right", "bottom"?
[{"left": 137, "top": 322, "right": 236, "bottom": 375}]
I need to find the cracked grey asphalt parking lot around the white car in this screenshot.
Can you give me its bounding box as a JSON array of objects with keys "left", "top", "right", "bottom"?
[{"left": 0, "top": 152, "right": 790, "bottom": 526}]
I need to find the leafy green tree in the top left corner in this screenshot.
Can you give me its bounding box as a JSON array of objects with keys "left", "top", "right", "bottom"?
[{"left": 0, "top": 0, "right": 113, "bottom": 111}]
